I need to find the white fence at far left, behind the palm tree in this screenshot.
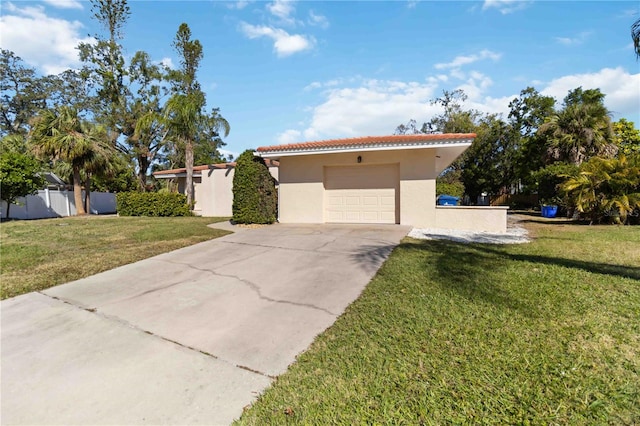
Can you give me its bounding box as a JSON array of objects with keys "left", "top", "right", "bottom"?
[{"left": 0, "top": 189, "right": 116, "bottom": 219}]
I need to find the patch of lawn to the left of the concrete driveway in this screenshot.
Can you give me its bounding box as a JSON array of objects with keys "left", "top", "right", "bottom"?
[{"left": 0, "top": 216, "right": 228, "bottom": 299}]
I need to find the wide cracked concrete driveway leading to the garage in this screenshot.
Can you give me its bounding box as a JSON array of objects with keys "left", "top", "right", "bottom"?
[{"left": 1, "top": 224, "right": 409, "bottom": 425}]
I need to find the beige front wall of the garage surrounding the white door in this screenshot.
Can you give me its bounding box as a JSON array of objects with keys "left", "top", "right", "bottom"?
[{"left": 278, "top": 149, "right": 436, "bottom": 227}]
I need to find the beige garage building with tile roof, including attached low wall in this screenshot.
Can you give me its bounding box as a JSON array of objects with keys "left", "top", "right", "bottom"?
[{"left": 257, "top": 133, "right": 507, "bottom": 232}]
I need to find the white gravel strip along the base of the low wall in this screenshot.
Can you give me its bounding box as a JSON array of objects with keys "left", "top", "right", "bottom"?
[{"left": 409, "top": 221, "right": 531, "bottom": 244}]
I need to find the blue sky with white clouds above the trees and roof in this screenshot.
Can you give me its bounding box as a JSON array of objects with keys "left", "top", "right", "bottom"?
[{"left": 0, "top": 0, "right": 640, "bottom": 158}]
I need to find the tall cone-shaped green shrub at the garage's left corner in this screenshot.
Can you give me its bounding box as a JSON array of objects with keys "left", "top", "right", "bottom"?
[{"left": 233, "top": 150, "right": 278, "bottom": 224}]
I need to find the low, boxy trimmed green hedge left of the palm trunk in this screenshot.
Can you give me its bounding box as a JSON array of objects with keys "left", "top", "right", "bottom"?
[{"left": 116, "top": 192, "right": 191, "bottom": 217}]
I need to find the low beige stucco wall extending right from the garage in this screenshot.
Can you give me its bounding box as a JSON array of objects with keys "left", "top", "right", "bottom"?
[{"left": 435, "top": 206, "right": 509, "bottom": 233}]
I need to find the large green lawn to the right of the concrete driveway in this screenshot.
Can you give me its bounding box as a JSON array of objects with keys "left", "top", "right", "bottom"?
[{"left": 237, "top": 219, "right": 640, "bottom": 425}]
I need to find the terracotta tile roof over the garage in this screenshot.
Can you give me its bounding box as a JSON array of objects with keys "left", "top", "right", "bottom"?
[{"left": 258, "top": 133, "right": 476, "bottom": 152}]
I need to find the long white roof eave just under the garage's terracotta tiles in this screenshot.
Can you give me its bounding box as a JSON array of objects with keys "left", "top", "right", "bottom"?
[{"left": 257, "top": 138, "right": 473, "bottom": 158}]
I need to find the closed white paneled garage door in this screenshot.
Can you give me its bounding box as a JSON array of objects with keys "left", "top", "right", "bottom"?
[{"left": 324, "top": 164, "right": 399, "bottom": 223}]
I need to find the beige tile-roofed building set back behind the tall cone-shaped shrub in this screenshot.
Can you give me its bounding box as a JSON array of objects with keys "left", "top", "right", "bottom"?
[{"left": 153, "top": 160, "right": 278, "bottom": 217}]
